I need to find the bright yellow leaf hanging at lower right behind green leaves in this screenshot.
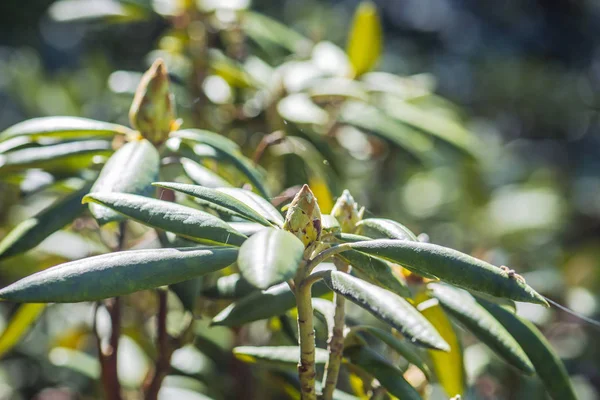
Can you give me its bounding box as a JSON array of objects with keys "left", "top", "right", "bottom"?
[{"left": 415, "top": 291, "right": 465, "bottom": 397}]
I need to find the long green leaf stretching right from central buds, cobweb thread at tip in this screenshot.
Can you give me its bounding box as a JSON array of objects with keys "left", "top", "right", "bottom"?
[{"left": 352, "top": 239, "right": 548, "bottom": 306}]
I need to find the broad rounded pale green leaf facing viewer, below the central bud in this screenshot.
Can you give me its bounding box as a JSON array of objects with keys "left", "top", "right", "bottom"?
[{"left": 238, "top": 228, "right": 304, "bottom": 289}]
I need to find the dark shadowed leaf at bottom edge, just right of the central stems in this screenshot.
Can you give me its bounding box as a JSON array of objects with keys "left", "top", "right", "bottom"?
[{"left": 344, "top": 346, "right": 421, "bottom": 400}]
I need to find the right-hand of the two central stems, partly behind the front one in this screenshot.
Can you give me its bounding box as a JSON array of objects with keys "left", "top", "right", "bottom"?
[{"left": 323, "top": 258, "right": 350, "bottom": 400}]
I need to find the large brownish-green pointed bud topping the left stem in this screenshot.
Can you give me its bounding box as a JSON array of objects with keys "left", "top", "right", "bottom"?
[{"left": 129, "top": 59, "right": 177, "bottom": 144}]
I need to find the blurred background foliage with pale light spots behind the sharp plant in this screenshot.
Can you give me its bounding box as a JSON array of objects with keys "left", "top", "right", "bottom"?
[{"left": 0, "top": 0, "right": 600, "bottom": 399}]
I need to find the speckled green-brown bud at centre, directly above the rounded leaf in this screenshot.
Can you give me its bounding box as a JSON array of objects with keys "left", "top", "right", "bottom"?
[{"left": 283, "top": 185, "right": 321, "bottom": 247}]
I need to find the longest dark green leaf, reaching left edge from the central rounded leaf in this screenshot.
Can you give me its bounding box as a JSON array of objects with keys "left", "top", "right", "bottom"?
[{"left": 0, "top": 247, "right": 238, "bottom": 303}]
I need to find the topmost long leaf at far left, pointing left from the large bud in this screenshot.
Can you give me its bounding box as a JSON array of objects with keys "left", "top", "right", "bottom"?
[{"left": 0, "top": 117, "right": 131, "bottom": 141}]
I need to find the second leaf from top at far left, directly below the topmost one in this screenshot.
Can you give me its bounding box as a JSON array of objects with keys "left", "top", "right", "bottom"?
[{"left": 0, "top": 140, "right": 112, "bottom": 171}]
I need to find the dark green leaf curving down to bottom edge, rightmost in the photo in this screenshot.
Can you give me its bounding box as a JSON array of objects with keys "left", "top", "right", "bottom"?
[{"left": 477, "top": 298, "right": 577, "bottom": 400}]
